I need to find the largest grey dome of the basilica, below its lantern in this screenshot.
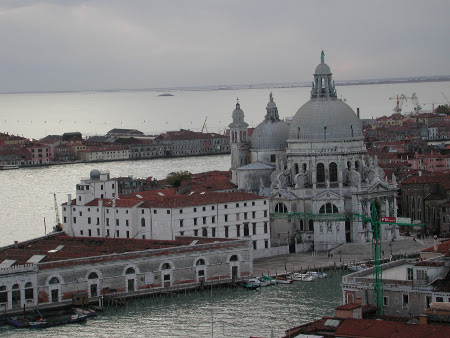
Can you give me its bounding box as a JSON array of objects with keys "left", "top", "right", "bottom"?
[{"left": 289, "top": 98, "right": 363, "bottom": 141}]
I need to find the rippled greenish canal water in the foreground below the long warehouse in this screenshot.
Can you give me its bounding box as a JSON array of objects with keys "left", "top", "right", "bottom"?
[{"left": 0, "top": 271, "right": 342, "bottom": 337}]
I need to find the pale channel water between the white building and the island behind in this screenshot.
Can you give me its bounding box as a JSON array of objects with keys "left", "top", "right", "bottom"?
[{"left": 0, "top": 155, "right": 230, "bottom": 246}]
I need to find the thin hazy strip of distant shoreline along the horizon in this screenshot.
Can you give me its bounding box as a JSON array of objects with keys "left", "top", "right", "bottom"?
[{"left": 0, "top": 75, "right": 450, "bottom": 96}]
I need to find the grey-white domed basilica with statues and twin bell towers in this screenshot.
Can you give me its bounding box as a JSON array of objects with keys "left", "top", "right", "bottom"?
[{"left": 229, "top": 52, "right": 398, "bottom": 251}]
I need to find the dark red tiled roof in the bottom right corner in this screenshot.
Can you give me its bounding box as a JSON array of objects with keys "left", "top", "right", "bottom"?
[{"left": 335, "top": 318, "right": 450, "bottom": 338}]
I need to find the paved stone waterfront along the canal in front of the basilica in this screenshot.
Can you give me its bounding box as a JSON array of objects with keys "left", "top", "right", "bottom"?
[{"left": 253, "top": 237, "right": 433, "bottom": 276}]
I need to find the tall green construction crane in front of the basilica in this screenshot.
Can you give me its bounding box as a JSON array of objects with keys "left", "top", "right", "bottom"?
[{"left": 270, "top": 202, "right": 424, "bottom": 314}]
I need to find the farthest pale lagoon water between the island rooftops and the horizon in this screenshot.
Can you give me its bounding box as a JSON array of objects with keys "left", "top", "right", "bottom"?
[{"left": 0, "top": 81, "right": 450, "bottom": 138}]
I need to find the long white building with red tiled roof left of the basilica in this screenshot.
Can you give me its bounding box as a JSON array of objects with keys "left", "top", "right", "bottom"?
[{"left": 62, "top": 170, "right": 271, "bottom": 257}]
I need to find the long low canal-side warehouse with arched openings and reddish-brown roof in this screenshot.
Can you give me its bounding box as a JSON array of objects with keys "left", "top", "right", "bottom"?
[{"left": 0, "top": 233, "right": 253, "bottom": 313}]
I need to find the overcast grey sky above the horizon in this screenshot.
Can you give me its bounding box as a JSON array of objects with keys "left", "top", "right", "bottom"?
[{"left": 0, "top": 0, "right": 450, "bottom": 93}]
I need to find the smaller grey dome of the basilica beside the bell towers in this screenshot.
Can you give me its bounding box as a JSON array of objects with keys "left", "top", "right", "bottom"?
[{"left": 251, "top": 120, "right": 289, "bottom": 150}]
